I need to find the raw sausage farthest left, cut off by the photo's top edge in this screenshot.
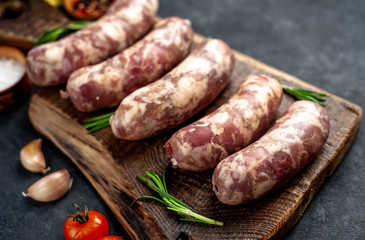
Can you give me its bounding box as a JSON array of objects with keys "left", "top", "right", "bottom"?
[{"left": 27, "top": 0, "right": 158, "bottom": 86}]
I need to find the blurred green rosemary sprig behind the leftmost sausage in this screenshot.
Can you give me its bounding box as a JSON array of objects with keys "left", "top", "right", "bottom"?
[{"left": 33, "top": 21, "right": 92, "bottom": 46}]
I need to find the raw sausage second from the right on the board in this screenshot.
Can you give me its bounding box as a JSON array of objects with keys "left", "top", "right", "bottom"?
[{"left": 165, "top": 74, "right": 283, "bottom": 172}]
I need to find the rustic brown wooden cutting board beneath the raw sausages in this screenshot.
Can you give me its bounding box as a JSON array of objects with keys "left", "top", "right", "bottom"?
[{"left": 29, "top": 35, "right": 362, "bottom": 240}]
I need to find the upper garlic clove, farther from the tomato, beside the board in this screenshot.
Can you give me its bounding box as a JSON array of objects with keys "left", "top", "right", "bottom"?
[{"left": 20, "top": 138, "right": 50, "bottom": 173}]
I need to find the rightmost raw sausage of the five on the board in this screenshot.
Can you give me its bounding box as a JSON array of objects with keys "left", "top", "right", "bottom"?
[{"left": 212, "top": 101, "right": 330, "bottom": 205}]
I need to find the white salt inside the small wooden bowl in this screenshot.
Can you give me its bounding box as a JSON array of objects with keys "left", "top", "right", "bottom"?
[{"left": 0, "top": 57, "right": 25, "bottom": 91}]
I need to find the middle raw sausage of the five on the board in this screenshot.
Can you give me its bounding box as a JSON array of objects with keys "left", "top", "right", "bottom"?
[{"left": 110, "top": 39, "right": 234, "bottom": 140}]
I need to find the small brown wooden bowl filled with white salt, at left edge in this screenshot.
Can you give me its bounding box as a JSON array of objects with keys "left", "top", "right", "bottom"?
[{"left": 0, "top": 46, "right": 31, "bottom": 111}]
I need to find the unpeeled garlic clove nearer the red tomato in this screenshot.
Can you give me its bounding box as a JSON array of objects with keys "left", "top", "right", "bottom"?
[{"left": 22, "top": 169, "right": 73, "bottom": 202}]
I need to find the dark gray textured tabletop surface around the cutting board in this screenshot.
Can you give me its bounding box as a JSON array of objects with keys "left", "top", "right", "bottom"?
[{"left": 0, "top": 0, "right": 365, "bottom": 240}]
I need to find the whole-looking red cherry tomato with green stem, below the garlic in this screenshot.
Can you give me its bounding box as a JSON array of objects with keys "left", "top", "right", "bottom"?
[{"left": 63, "top": 204, "right": 109, "bottom": 240}]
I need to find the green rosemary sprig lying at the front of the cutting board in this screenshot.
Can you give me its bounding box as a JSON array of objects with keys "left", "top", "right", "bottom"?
[{"left": 132, "top": 165, "right": 223, "bottom": 226}]
